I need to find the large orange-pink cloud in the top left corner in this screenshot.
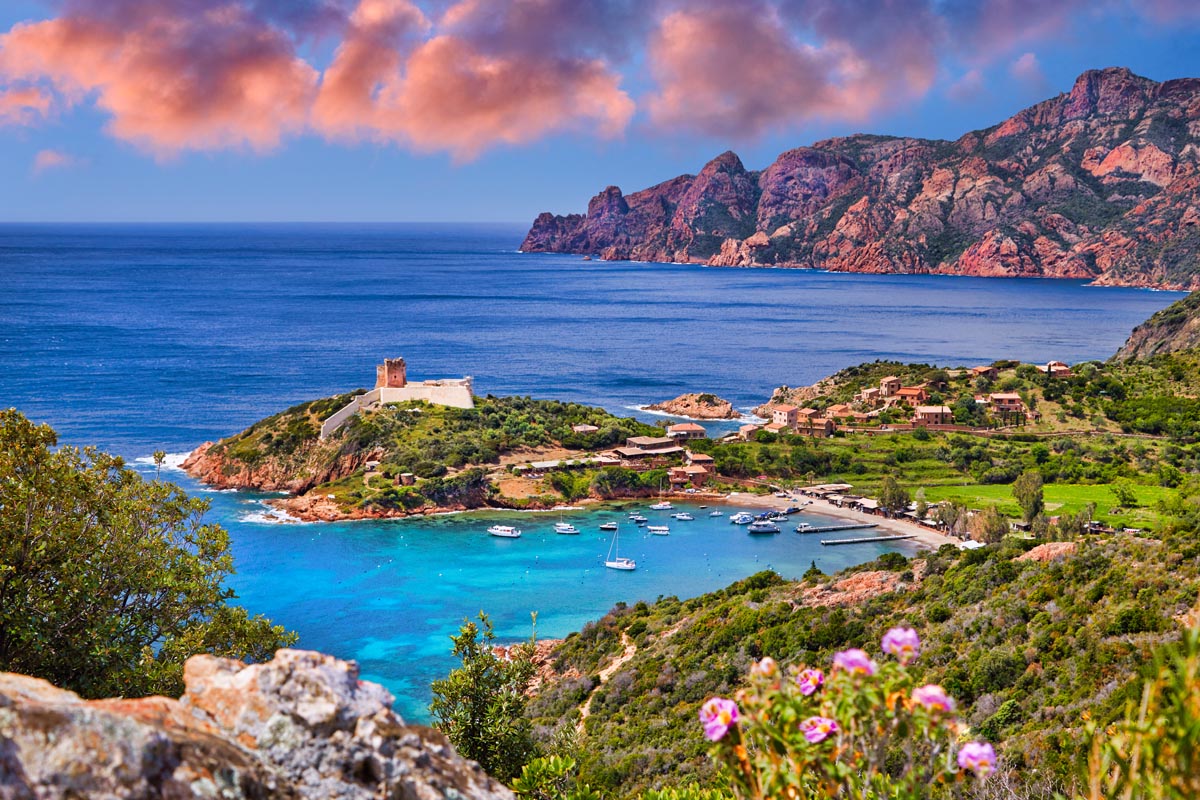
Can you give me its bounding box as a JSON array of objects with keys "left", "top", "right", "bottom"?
[{"left": 0, "top": 0, "right": 317, "bottom": 156}]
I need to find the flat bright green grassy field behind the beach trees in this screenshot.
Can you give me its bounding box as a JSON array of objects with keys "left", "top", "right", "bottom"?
[{"left": 925, "top": 483, "right": 1175, "bottom": 528}]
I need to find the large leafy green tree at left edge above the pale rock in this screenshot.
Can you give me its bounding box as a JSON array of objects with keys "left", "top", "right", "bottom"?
[{"left": 0, "top": 409, "right": 295, "bottom": 697}]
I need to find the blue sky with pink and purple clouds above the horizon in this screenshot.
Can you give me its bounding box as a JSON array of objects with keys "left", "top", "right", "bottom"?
[{"left": 0, "top": 0, "right": 1200, "bottom": 223}]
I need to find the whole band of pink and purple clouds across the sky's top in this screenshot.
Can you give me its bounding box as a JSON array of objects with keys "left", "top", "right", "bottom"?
[{"left": 0, "top": 0, "right": 1200, "bottom": 161}]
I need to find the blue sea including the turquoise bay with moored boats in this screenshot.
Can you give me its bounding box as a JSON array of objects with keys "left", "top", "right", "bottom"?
[{"left": 0, "top": 223, "right": 1182, "bottom": 721}]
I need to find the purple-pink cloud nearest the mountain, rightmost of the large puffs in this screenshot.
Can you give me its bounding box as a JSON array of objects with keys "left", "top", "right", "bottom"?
[{"left": 647, "top": 0, "right": 936, "bottom": 137}]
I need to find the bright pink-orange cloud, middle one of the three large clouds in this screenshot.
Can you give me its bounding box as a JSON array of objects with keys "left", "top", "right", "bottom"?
[{"left": 313, "top": 0, "right": 634, "bottom": 160}]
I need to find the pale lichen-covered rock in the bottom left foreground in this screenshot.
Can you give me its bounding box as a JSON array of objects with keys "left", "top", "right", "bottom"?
[{"left": 0, "top": 650, "right": 512, "bottom": 800}]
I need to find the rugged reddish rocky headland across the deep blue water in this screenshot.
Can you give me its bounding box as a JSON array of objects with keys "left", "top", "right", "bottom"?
[{"left": 521, "top": 68, "right": 1200, "bottom": 289}]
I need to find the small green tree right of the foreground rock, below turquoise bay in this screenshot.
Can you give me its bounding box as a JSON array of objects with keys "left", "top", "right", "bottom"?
[{"left": 430, "top": 612, "right": 535, "bottom": 783}]
